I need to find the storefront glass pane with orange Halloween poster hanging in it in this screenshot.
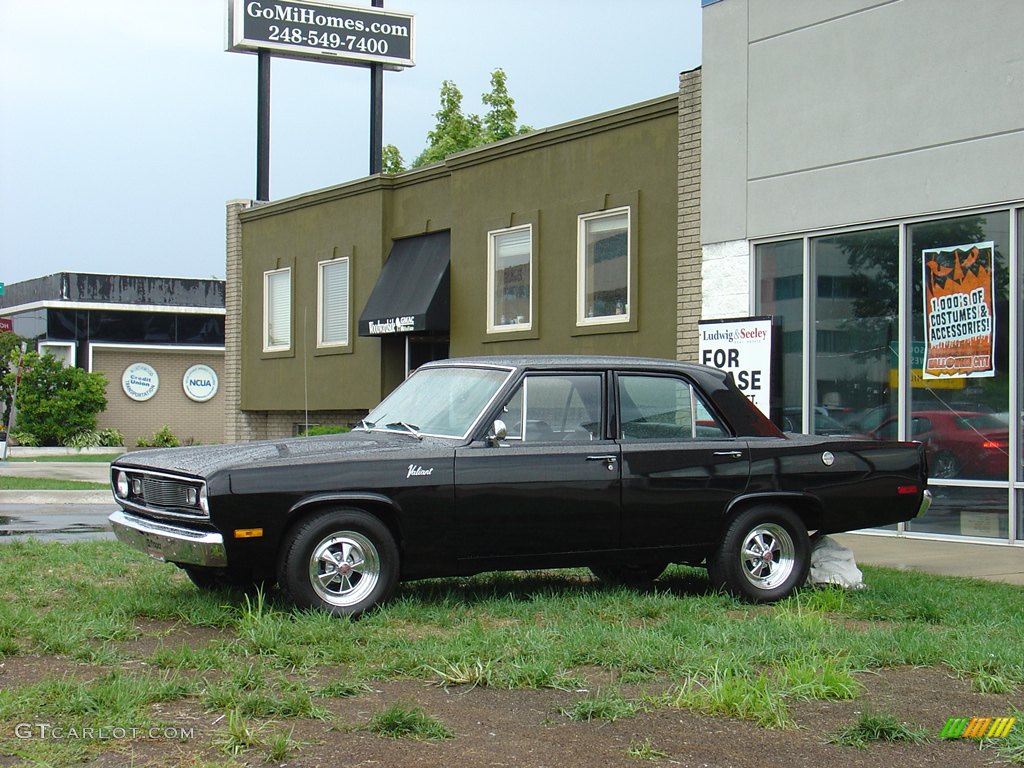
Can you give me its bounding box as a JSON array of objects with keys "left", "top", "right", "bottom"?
[{"left": 907, "top": 212, "right": 1011, "bottom": 481}]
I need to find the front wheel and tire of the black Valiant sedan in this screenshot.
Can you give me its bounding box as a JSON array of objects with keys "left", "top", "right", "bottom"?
[{"left": 278, "top": 508, "right": 398, "bottom": 616}]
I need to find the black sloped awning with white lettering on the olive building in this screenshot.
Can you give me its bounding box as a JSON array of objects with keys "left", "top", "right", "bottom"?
[{"left": 359, "top": 230, "right": 452, "bottom": 336}]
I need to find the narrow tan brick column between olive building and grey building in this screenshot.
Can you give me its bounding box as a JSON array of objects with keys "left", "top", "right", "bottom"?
[{"left": 676, "top": 69, "right": 702, "bottom": 361}]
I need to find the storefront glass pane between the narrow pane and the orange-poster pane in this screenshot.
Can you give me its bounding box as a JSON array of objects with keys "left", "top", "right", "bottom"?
[{"left": 811, "top": 226, "right": 899, "bottom": 434}]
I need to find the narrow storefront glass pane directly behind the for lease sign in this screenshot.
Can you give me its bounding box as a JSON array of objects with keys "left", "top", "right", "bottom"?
[{"left": 754, "top": 240, "right": 804, "bottom": 432}]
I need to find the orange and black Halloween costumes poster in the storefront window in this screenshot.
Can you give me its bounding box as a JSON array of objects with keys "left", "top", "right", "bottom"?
[{"left": 922, "top": 241, "right": 995, "bottom": 379}]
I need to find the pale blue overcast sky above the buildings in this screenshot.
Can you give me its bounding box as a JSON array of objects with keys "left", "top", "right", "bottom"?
[{"left": 0, "top": 0, "right": 700, "bottom": 284}]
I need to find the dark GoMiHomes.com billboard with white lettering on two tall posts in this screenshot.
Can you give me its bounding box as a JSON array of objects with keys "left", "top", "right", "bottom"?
[{"left": 227, "top": 0, "right": 415, "bottom": 69}]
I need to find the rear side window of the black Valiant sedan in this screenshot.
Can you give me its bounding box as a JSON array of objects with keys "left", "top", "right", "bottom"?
[{"left": 618, "top": 374, "right": 729, "bottom": 440}]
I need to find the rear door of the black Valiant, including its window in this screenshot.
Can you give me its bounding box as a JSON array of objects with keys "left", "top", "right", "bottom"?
[{"left": 614, "top": 373, "right": 750, "bottom": 548}]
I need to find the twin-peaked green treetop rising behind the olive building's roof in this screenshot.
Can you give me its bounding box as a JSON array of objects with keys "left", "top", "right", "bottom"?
[{"left": 413, "top": 69, "right": 532, "bottom": 168}]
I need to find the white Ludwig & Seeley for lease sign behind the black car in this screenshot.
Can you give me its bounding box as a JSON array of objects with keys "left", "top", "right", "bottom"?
[{"left": 697, "top": 317, "right": 771, "bottom": 416}]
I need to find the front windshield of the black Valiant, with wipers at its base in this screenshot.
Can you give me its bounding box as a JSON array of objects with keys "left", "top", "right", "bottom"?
[{"left": 360, "top": 367, "right": 511, "bottom": 438}]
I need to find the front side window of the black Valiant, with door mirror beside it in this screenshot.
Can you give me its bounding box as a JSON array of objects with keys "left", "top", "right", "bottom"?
[{"left": 501, "top": 374, "right": 601, "bottom": 442}]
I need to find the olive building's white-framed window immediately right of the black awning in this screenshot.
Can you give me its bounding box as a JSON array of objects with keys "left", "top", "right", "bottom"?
[{"left": 487, "top": 225, "right": 534, "bottom": 333}]
